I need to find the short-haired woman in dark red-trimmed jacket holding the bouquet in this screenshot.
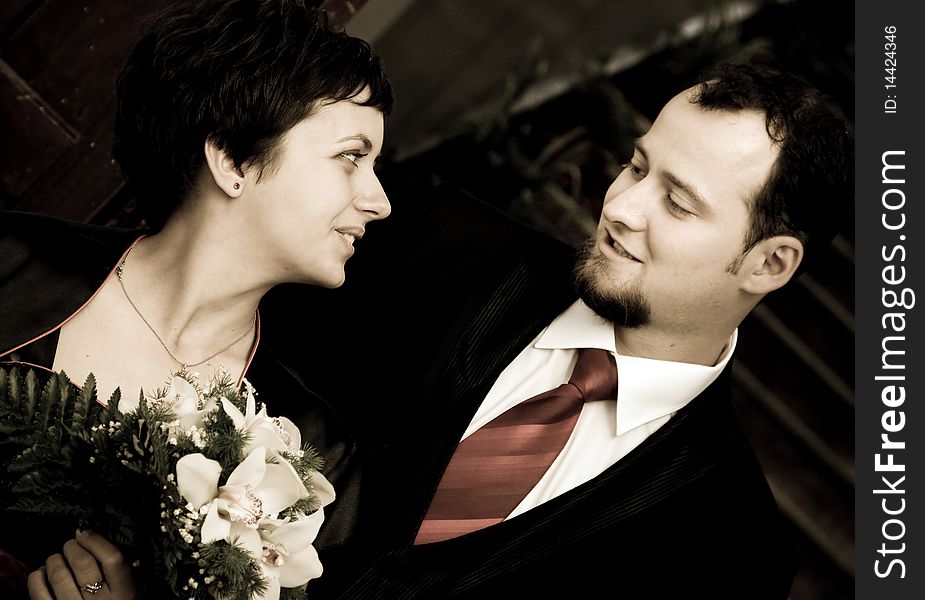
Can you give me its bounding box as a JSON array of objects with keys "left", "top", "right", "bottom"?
[{"left": 0, "top": 0, "right": 392, "bottom": 599}]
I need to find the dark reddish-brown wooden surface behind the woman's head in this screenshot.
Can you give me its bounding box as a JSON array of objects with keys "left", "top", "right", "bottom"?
[{"left": 0, "top": 0, "right": 365, "bottom": 224}]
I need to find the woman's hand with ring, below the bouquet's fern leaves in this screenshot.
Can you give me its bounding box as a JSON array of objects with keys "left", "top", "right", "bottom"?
[{"left": 27, "top": 531, "right": 136, "bottom": 600}]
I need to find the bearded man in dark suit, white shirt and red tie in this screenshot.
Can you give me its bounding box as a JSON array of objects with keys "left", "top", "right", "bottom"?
[{"left": 265, "top": 66, "right": 853, "bottom": 599}]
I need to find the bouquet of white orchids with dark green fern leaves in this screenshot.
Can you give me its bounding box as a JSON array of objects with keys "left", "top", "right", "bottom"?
[{"left": 0, "top": 368, "right": 334, "bottom": 600}]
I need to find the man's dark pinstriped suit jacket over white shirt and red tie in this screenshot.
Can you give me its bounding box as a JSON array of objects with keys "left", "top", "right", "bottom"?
[{"left": 266, "top": 171, "right": 796, "bottom": 600}]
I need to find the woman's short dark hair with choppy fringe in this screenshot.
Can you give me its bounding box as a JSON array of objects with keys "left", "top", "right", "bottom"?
[{"left": 113, "top": 0, "right": 392, "bottom": 228}]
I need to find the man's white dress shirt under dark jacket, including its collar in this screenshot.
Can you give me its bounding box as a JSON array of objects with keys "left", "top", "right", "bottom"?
[{"left": 463, "top": 300, "right": 738, "bottom": 518}]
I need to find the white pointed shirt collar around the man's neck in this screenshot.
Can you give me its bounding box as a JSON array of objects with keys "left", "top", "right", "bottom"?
[{"left": 534, "top": 300, "right": 738, "bottom": 435}]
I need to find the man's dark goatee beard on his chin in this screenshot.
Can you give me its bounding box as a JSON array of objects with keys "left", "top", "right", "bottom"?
[{"left": 574, "top": 239, "right": 651, "bottom": 327}]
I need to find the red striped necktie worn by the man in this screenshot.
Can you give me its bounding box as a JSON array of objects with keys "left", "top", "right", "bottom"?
[{"left": 414, "top": 348, "right": 617, "bottom": 544}]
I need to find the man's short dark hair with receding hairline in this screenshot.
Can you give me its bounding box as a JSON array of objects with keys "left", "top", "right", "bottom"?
[{"left": 693, "top": 63, "right": 854, "bottom": 266}]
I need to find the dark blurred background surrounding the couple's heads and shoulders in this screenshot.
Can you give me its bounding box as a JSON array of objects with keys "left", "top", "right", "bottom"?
[{"left": 0, "top": 0, "right": 855, "bottom": 600}]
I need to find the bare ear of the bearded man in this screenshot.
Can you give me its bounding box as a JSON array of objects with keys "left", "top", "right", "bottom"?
[{"left": 740, "top": 235, "right": 803, "bottom": 296}]
